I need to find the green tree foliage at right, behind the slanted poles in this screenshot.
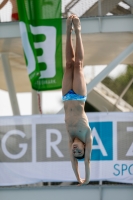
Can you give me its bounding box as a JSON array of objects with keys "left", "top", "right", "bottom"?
[{"left": 102, "top": 65, "right": 133, "bottom": 106}]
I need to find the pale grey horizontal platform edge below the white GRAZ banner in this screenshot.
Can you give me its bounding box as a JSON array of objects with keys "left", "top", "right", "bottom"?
[{"left": 0, "top": 185, "right": 133, "bottom": 200}]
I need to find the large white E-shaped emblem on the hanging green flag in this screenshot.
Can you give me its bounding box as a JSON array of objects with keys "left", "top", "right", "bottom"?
[{"left": 30, "top": 26, "right": 56, "bottom": 79}]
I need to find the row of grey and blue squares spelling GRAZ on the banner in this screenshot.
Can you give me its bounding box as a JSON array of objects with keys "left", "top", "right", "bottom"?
[{"left": 0, "top": 122, "right": 133, "bottom": 162}]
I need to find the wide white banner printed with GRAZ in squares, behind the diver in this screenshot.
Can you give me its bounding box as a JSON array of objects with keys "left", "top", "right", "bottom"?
[{"left": 0, "top": 113, "right": 133, "bottom": 186}]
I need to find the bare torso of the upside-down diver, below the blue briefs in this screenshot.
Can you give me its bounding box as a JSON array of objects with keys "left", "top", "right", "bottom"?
[{"left": 64, "top": 101, "right": 91, "bottom": 143}]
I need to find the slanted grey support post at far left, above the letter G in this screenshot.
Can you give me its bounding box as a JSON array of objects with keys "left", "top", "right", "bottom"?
[{"left": 1, "top": 54, "right": 20, "bottom": 115}]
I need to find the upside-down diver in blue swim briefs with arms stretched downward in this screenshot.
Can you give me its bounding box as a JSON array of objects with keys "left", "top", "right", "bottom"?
[{"left": 62, "top": 15, "right": 92, "bottom": 185}]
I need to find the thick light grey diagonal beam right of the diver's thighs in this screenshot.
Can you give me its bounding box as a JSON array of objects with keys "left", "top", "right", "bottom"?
[{"left": 87, "top": 43, "right": 133, "bottom": 93}]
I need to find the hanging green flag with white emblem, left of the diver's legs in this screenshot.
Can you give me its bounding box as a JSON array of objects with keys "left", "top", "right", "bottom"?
[{"left": 17, "top": 0, "right": 63, "bottom": 91}]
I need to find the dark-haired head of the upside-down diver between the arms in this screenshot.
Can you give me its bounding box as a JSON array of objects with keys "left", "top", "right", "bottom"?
[{"left": 72, "top": 138, "right": 85, "bottom": 159}]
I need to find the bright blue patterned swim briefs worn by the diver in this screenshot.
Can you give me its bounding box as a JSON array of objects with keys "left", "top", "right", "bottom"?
[{"left": 62, "top": 90, "right": 87, "bottom": 102}]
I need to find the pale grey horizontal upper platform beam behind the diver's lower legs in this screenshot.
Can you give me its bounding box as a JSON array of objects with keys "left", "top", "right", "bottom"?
[{"left": 0, "top": 15, "right": 133, "bottom": 38}]
